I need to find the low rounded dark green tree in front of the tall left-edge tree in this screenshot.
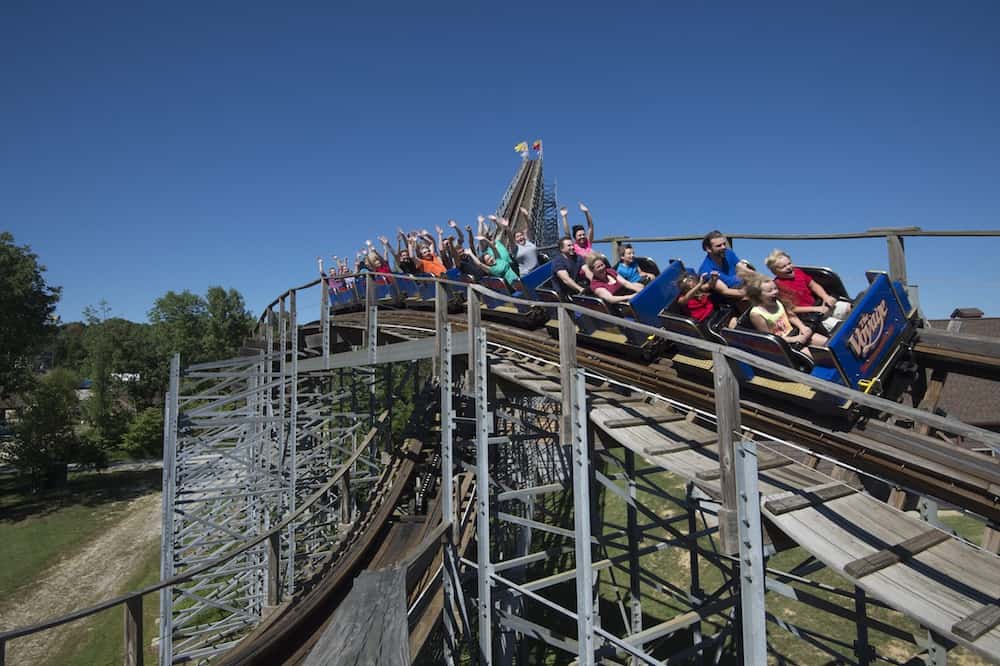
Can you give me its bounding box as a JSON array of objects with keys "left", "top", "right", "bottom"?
[{"left": 3, "top": 369, "right": 81, "bottom": 489}]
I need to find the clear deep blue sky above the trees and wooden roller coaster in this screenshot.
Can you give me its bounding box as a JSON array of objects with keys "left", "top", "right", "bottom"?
[{"left": 0, "top": 0, "right": 1000, "bottom": 321}]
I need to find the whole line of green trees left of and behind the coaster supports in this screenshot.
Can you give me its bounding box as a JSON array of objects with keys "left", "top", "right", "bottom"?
[{"left": 0, "top": 232, "right": 254, "bottom": 489}]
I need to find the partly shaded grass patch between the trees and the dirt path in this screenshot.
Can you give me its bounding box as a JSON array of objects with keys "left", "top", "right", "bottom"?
[{"left": 0, "top": 470, "right": 160, "bottom": 599}]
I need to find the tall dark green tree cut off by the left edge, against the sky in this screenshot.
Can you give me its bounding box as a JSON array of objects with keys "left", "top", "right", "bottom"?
[{"left": 0, "top": 231, "right": 59, "bottom": 395}]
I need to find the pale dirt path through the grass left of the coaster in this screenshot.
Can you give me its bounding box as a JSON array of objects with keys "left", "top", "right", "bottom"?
[{"left": 0, "top": 493, "right": 161, "bottom": 666}]
